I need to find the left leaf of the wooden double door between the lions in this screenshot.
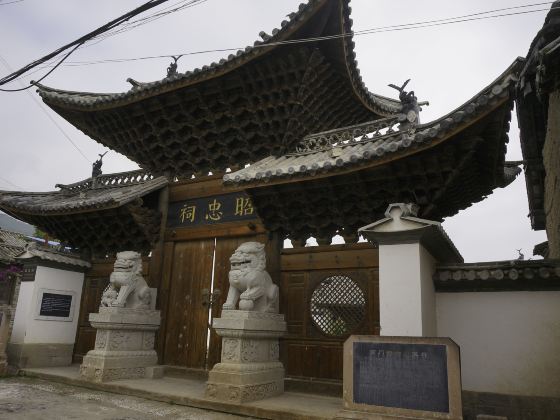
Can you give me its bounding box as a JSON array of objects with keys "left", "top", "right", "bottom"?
[{"left": 163, "top": 238, "right": 215, "bottom": 369}]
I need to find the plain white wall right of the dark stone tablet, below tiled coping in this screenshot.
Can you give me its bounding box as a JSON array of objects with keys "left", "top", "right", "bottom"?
[{"left": 436, "top": 292, "right": 560, "bottom": 397}]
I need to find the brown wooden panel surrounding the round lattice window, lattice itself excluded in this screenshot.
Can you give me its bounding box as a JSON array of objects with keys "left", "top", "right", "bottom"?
[{"left": 280, "top": 244, "right": 379, "bottom": 381}]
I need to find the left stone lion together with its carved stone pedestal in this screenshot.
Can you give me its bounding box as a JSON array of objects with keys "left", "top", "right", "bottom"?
[{"left": 80, "top": 251, "right": 163, "bottom": 382}]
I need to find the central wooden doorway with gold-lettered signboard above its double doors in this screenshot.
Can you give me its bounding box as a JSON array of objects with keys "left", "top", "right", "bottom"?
[{"left": 158, "top": 177, "right": 280, "bottom": 369}]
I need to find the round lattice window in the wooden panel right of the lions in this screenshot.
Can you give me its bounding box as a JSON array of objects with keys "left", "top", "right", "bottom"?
[{"left": 310, "top": 276, "right": 366, "bottom": 337}]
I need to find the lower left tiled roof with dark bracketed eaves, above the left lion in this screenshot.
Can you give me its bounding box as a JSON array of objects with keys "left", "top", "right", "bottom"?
[{"left": 0, "top": 171, "right": 168, "bottom": 256}]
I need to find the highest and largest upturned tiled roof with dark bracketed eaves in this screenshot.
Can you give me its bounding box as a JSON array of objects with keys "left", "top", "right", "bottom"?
[{"left": 38, "top": 0, "right": 401, "bottom": 178}]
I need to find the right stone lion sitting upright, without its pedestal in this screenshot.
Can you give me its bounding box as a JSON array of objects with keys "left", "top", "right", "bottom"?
[{"left": 222, "top": 242, "right": 278, "bottom": 313}]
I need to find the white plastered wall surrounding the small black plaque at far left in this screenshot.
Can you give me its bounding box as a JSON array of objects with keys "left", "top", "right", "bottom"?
[{"left": 10, "top": 266, "right": 84, "bottom": 344}]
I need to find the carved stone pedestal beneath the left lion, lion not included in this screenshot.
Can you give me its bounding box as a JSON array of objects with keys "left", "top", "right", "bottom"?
[{"left": 80, "top": 307, "right": 160, "bottom": 382}]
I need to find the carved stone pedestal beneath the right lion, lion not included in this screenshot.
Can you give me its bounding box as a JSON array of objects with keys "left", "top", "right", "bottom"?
[{"left": 206, "top": 310, "right": 286, "bottom": 403}]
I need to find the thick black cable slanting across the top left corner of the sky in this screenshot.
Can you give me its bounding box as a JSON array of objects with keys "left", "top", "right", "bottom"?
[{"left": 0, "top": 0, "right": 172, "bottom": 89}]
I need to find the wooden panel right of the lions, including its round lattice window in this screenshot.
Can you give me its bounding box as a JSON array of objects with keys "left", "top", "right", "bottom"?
[{"left": 280, "top": 244, "right": 379, "bottom": 381}]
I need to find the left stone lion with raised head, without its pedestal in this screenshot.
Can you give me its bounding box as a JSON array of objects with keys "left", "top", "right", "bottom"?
[{"left": 101, "top": 251, "right": 152, "bottom": 309}]
